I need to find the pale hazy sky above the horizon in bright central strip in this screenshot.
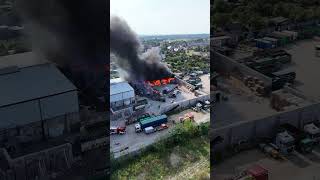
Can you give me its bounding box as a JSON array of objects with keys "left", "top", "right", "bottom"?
[{"left": 110, "top": 0, "right": 210, "bottom": 35}]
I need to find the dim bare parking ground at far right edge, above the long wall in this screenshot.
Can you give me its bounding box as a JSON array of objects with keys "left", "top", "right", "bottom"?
[{"left": 286, "top": 40, "right": 320, "bottom": 100}]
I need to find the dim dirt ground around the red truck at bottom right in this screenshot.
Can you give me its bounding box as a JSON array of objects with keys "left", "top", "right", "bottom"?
[{"left": 211, "top": 146, "right": 320, "bottom": 180}]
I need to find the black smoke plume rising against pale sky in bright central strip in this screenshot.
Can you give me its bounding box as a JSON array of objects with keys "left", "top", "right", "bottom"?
[{"left": 110, "top": 16, "right": 172, "bottom": 80}]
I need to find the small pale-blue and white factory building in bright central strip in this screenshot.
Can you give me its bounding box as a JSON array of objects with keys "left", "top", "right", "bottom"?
[{"left": 110, "top": 78, "right": 135, "bottom": 120}]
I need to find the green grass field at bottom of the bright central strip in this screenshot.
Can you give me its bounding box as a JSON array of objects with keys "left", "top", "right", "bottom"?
[{"left": 111, "top": 121, "right": 210, "bottom": 179}]
